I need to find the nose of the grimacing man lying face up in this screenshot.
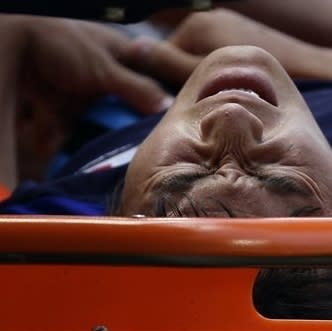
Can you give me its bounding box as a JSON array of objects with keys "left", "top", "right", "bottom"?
[{"left": 200, "top": 103, "right": 263, "bottom": 146}]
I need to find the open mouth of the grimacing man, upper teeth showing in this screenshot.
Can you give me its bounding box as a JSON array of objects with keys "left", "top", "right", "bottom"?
[{"left": 197, "top": 69, "right": 278, "bottom": 106}]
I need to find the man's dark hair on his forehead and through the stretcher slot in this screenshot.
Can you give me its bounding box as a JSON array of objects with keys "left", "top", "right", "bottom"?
[{"left": 108, "top": 184, "right": 332, "bottom": 319}]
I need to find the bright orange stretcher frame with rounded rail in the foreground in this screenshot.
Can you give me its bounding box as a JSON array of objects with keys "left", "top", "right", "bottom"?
[{"left": 0, "top": 216, "right": 332, "bottom": 331}]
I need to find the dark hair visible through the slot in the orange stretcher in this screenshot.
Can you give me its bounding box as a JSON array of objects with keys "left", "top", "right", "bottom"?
[{"left": 253, "top": 267, "right": 332, "bottom": 319}]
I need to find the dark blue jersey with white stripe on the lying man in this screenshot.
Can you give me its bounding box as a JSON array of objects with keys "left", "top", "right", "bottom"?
[{"left": 0, "top": 81, "right": 332, "bottom": 216}]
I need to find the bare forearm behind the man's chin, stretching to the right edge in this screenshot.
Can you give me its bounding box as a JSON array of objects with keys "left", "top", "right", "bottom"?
[{"left": 170, "top": 9, "right": 332, "bottom": 79}]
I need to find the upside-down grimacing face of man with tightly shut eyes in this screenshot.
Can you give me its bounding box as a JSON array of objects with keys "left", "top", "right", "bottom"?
[{"left": 121, "top": 46, "right": 332, "bottom": 217}]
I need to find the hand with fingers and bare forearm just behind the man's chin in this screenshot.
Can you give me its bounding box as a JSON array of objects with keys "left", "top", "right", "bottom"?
[{"left": 124, "top": 9, "right": 332, "bottom": 84}]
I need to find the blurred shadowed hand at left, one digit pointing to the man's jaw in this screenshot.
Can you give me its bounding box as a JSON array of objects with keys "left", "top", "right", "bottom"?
[{"left": 21, "top": 17, "right": 172, "bottom": 114}]
